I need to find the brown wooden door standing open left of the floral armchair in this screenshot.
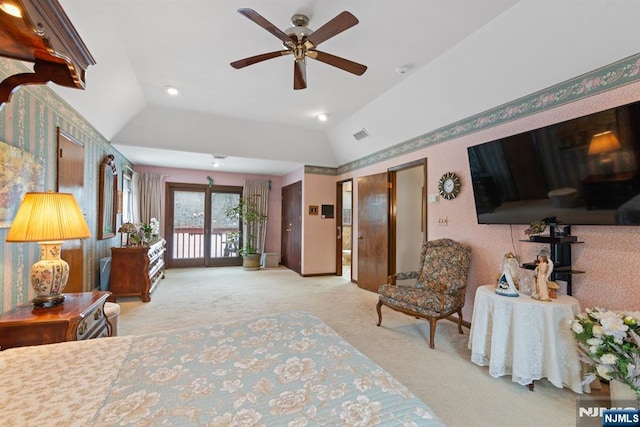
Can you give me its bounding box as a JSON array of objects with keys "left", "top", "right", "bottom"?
[{"left": 356, "top": 172, "right": 389, "bottom": 292}]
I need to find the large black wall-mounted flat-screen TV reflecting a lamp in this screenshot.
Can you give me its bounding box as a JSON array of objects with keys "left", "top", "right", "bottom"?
[{"left": 467, "top": 102, "right": 640, "bottom": 225}]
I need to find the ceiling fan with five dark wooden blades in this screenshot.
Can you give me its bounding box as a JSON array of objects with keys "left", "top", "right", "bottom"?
[{"left": 231, "top": 9, "right": 367, "bottom": 90}]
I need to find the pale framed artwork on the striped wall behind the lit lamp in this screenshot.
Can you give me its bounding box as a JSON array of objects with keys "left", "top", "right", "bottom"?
[{"left": 0, "top": 142, "right": 44, "bottom": 228}]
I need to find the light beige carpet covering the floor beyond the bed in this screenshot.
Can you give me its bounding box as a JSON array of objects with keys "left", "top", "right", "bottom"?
[{"left": 118, "top": 267, "right": 604, "bottom": 427}]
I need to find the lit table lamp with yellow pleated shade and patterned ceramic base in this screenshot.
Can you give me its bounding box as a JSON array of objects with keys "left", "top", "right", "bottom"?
[{"left": 6, "top": 191, "right": 91, "bottom": 307}]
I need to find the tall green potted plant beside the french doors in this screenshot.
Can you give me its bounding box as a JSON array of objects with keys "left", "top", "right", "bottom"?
[{"left": 224, "top": 196, "right": 267, "bottom": 270}]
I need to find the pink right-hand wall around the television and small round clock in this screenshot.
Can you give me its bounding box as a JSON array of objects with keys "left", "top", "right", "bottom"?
[{"left": 336, "top": 83, "right": 640, "bottom": 320}]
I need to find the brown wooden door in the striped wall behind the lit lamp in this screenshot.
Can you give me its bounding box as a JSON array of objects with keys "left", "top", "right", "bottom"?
[{"left": 57, "top": 128, "right": 87, "bottom": 293}]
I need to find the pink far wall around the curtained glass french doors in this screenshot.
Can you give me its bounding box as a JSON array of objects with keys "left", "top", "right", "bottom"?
[{"left": 134, "top": 166, "right": 282, "bottom": 257}]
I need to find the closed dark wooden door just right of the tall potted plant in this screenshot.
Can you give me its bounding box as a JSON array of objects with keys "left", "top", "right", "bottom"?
[{"left": 280, "top": 181, "right": 302, "bottom": 274}]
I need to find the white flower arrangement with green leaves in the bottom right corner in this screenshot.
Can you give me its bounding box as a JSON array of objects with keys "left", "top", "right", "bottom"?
[{"left": 571, "top": 308, "right": 640, "bottom": 401}]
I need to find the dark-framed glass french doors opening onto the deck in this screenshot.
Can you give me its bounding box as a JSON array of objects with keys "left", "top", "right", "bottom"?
[{"left": 165, "top": 183, "right": 242, "bottom": 267}]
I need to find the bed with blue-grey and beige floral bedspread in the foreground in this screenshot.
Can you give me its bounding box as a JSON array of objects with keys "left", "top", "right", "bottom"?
[{"left": 0, "top": 312, "right": 444, "bottom": 426}]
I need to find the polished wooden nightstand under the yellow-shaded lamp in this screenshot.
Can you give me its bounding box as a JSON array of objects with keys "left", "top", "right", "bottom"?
[{"left": 0, "top": 292, "right": 111, "bottom": 350}]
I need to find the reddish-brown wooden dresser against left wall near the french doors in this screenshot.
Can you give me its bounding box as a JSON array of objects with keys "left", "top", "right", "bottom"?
[{"left": 109, "top": 239, "right": 166, "bottom": 302}]
